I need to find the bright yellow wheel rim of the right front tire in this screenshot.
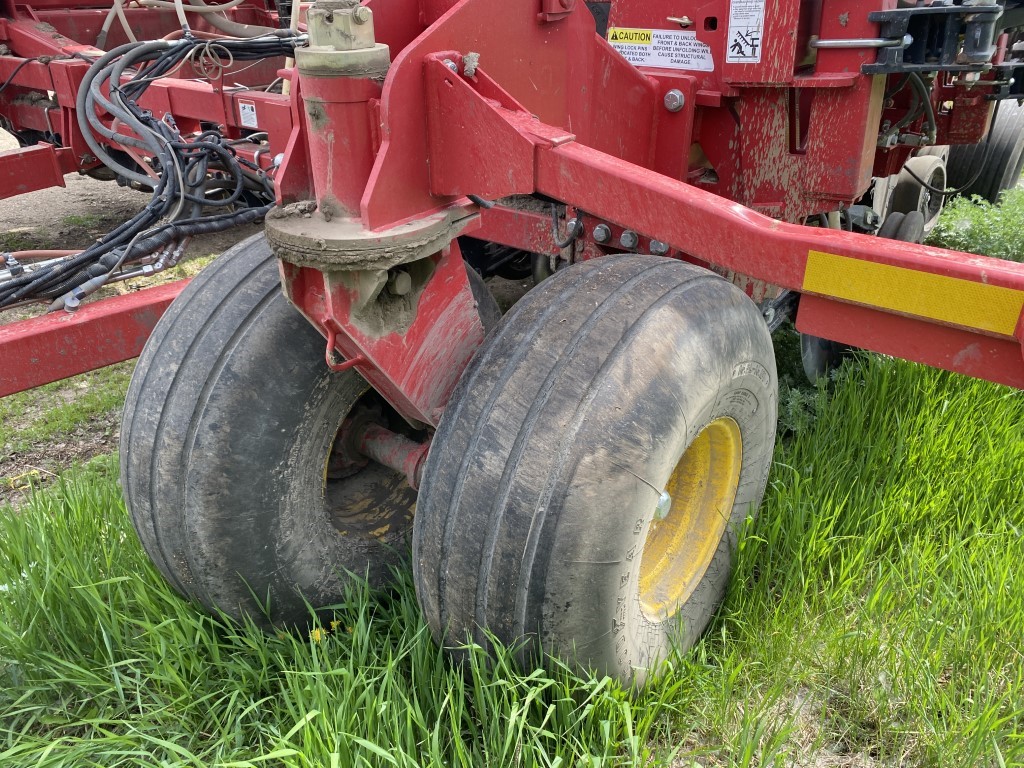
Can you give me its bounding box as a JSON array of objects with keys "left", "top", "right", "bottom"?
[{"left": 639, "top": 417, "right": 742, "bottom": 622}]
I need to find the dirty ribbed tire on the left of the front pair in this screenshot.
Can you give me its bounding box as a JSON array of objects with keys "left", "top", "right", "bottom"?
[{"left": 121, "top": 236, "right": 416, "bottom": 626}]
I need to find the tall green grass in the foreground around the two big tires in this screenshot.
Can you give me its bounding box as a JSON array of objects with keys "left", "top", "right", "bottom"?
[{"left": 0, "top": 356, "right": 1024, "bottom": 768}]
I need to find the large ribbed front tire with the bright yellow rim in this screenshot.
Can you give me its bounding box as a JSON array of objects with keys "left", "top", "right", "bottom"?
[{"left": 413, "top": 256, "right": 777, "bottom": 685}]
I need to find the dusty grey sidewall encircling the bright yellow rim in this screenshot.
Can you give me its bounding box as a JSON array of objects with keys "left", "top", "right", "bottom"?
[{"left": 542, "top": 292, "right": 777, "bottom": 684}]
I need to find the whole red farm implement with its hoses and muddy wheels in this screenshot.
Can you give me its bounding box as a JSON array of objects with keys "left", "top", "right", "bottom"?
[{"left": 0, "top": 0, "right": 1024, "bottom": 682}]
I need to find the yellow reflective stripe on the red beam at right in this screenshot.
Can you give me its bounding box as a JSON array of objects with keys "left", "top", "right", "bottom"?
[{"left": 803, "top": 251, "right": 1024, "bottom": 336}]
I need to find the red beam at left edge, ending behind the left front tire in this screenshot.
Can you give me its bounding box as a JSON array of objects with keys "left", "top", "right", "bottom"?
[{"left": 0, "top": 280, "right": 188, "bottom": 397}]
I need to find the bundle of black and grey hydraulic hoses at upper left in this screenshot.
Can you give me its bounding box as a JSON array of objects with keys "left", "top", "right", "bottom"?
[{"left": 0, "top": 30, "right": 304, "bottom": 310}]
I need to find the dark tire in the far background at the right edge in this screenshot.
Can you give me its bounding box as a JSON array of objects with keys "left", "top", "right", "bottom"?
[{"left": 946, "top": 100, "right": 1024, "bottom": 203}]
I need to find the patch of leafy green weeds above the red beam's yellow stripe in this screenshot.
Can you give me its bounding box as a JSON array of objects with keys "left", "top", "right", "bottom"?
[{"left": 928, "top": 187, "right": 1024, "bottom": 261}]
